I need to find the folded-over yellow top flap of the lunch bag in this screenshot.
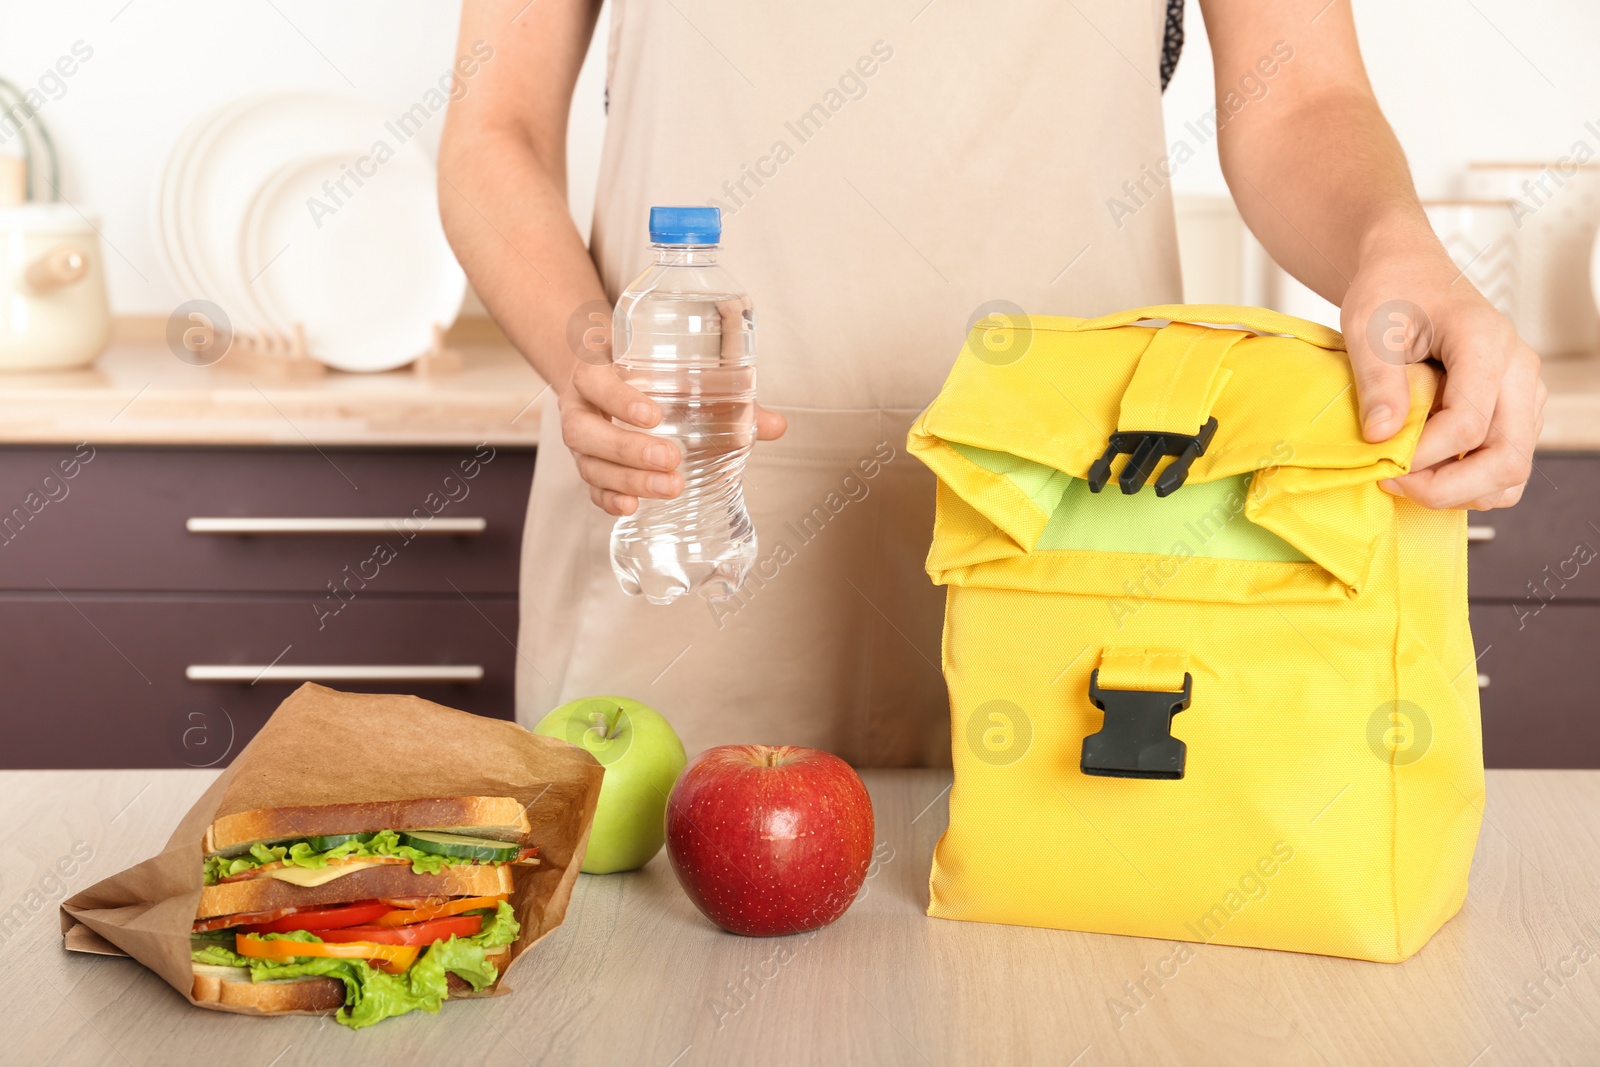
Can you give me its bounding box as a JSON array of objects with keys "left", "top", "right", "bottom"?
[{"left": 907, "top": 304, "right": 1438, "bottom": 592}]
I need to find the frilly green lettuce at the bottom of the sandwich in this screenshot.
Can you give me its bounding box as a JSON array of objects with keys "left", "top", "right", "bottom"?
[{"left": 190, "top": 901, "right": 522, "bottom": 1030}]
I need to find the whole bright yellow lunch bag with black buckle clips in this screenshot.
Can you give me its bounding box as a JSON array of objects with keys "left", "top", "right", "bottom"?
[{"left": 909, "top": 306, "right": 1483, "bottom": 961}]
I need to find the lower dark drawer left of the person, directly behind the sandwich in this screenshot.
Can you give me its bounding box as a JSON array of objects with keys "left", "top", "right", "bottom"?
[{"left": 0, "top": 592, "right": 517, "bottom": 769}]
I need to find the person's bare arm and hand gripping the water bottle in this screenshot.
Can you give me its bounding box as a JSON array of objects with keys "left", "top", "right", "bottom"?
[{"left": 438, "top": 0, "right": 683, "bottom": 515}]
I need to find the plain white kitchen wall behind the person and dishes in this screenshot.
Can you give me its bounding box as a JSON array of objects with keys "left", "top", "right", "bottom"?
[{"left": 0, "top": 0, "right": 1600, "bottom": 315}]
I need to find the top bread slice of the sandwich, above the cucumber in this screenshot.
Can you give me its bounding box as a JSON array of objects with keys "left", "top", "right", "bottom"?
[{"left": 202, "top": 797, "right": 531, "bottom": 856}]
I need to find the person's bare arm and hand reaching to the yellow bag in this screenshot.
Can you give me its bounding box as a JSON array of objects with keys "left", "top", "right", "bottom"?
[{"left": 1200, "top": 0, "right": 1544, "bottom": 509}]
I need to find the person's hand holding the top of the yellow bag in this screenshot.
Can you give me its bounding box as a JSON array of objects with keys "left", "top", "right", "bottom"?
[{"left": 1341, "top": 232, "right": 1546, "bottom": 510}]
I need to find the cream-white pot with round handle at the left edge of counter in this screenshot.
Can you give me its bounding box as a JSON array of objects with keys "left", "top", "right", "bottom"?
[{"left": 0, "top": 203, "right": 110, "bottom": 371}]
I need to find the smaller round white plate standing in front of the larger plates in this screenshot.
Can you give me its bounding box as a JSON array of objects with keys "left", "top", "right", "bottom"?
[{"left": 238, "top": 150, "right": 467, "bottom": 371}]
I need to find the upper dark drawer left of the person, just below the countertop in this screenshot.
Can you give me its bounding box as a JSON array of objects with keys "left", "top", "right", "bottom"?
[{"left": 0, "top": 446, "right": 533, "bottom": 597}]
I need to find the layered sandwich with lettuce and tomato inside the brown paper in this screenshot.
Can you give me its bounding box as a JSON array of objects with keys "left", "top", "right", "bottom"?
[{"left": 190, "top": 797, "right": 539, "bottom": 1029}]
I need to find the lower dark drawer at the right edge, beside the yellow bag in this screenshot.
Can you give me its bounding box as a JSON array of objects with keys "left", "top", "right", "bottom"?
[{"left": 1472, "top": 601, "right": 1600, "bottom": 768}]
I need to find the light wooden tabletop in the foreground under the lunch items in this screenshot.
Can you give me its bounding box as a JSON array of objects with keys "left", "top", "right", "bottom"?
[{"left": 0, "top": 771, "right": 1600, "bottom": 1067}]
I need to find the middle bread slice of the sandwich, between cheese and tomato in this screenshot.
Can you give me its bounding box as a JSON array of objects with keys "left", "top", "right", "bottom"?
[{"left": 195, "top": 864, "right": 512, "bottom": 920}]
